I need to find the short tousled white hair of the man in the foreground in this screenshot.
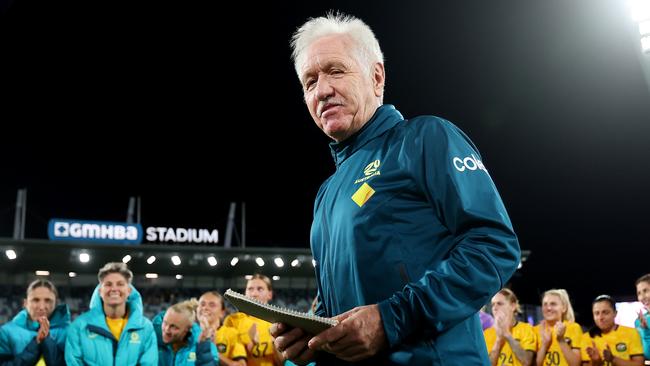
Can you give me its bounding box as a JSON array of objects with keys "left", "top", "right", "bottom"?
[{"left": 291, "top": 12, "right": 384, "bottom": 81}]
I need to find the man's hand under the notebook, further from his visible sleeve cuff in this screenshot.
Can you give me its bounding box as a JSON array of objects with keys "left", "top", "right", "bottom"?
[{"left": 271, "top": 323, "right": 316, "bottom": 365}]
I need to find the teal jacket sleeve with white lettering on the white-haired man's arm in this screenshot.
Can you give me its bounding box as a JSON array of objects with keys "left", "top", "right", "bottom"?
[{"left": 379, "top": 119, "right": 520, "bottom": 347}]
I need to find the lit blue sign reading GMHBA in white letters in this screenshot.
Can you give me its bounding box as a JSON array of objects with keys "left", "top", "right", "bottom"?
[{"left": 47, "top": 219, "right": 142, "bottom": 244}]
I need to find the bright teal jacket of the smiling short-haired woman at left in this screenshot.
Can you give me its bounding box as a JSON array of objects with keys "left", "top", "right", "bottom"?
[{"left": 65, "top": 286, "right": 158, "bottom": 366}]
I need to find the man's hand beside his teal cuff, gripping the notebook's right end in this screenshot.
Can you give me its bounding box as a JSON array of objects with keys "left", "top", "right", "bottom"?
[{"left": 308, "top": 304, "right": 388, "bottom": 362}]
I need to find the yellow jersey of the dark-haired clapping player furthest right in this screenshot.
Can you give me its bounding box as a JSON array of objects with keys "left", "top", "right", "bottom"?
[{"left": 580, "top": 324, "right": 643, "bottom": 366}]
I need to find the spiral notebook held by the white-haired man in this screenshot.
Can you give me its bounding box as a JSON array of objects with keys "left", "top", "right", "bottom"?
[{"left": 224, "top": 289, "right": 338, "bottom": 334}]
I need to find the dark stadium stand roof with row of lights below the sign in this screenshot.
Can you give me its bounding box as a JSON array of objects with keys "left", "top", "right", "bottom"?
[{"left": 0, "top": 238, "right": 314, "bottom": 277}]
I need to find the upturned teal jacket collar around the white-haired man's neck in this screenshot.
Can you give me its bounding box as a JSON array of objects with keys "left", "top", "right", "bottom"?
[{"left": 330, "top": 104, "right": 404, "bottom": 168}]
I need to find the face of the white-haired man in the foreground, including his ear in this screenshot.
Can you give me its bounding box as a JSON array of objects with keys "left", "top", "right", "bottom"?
[{"left": 300, "top": 35, "right": 384, "bottom": 141}]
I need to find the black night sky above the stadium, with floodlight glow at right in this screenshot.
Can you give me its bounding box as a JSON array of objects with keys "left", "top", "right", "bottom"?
[{"left": 0, "top": 0, "right": 650, "bottom": 326}]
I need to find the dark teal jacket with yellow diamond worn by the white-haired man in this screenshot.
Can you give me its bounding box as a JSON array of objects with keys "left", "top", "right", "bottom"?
[{"left": 311, "top": 105, "right": 520, "bottom": 366}]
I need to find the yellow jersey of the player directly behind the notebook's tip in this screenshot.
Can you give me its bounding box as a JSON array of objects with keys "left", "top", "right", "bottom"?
[{"left": 223, "top": 312, "right": 276, "bottom": 366}]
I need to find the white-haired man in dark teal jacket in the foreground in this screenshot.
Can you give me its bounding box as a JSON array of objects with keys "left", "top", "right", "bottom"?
[{"left": 271, "top": 14, "right": 520, "bottom": 365}]
